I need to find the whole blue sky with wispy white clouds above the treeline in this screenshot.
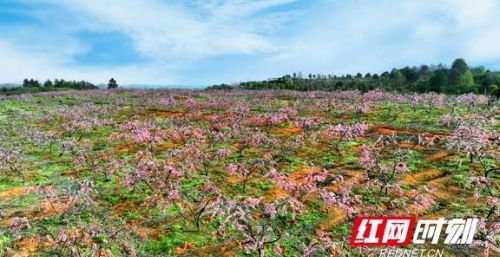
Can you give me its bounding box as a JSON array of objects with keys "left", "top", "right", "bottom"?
[{"left": 0, "top": 0, "right": 500, "bottom": 85}]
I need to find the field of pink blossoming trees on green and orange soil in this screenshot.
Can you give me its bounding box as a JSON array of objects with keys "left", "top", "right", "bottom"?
[{"left": 0, "top": 89, "right": 500, "bottom": 257}]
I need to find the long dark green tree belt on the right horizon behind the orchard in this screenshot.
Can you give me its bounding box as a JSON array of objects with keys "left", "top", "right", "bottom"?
[{"left": 209, "top": 58, "right": 500, "bottom": 96}]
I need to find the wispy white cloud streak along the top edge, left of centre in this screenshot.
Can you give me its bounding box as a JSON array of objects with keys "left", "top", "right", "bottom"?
[{"left": 40, "top": 0, "right": 293, "bottom": 60}]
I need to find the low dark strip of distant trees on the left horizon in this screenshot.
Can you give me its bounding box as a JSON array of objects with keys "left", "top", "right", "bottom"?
[{"left": 0, "top": 78, "right": 118, "bottom": 95}]
